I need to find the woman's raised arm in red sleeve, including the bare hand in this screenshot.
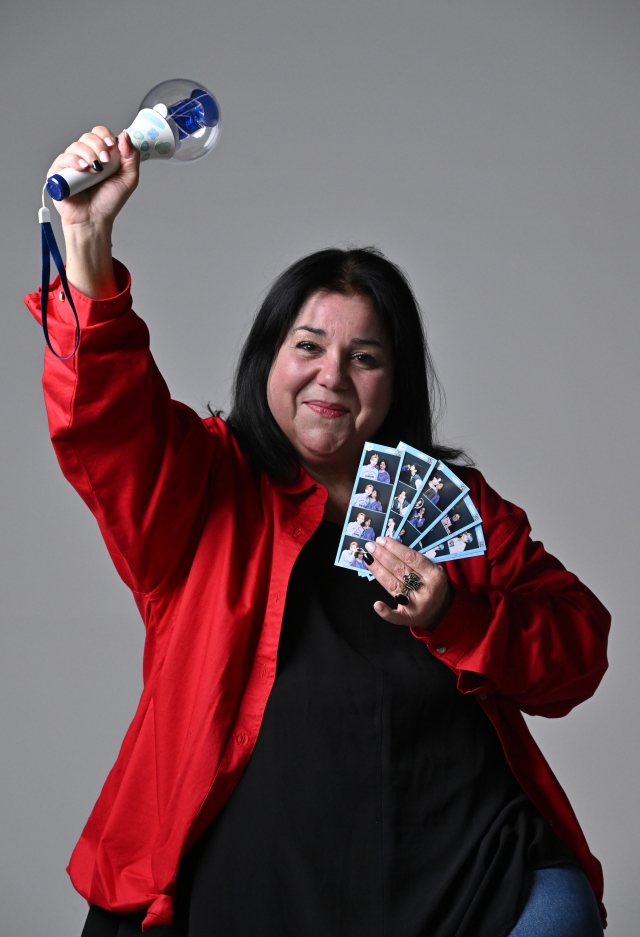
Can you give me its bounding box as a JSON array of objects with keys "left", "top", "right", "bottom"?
[{"left": 26, "top": 127, "right": 216, "bottom": 593}]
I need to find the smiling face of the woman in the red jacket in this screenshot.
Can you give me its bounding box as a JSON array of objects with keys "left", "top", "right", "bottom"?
[{"left": 267, "top": 292, "right": 393, "bottom": 471}]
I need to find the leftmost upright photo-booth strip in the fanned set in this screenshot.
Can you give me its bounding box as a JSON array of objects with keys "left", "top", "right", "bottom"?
[{"left": 335, "top": 442, "right": 401, "bottom": 578}]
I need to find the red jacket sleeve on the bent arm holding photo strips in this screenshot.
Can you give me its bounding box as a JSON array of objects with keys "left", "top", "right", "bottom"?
[{"left": 414, "top": 472, "right": 610, "bottom": 716}]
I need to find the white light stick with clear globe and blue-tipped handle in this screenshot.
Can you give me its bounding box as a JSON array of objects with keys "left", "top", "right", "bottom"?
[{"left": 46, "top": 78, "right": 220, "bottom": 201}]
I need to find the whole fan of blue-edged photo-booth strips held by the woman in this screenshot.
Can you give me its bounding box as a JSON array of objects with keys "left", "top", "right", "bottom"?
[{"left": 335, "top": 442, "right": 486, "bottom": 579}]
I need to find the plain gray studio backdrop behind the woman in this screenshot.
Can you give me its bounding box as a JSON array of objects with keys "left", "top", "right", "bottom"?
[{"left": 0, "top": 0, "right": 640, "bottom": 937}]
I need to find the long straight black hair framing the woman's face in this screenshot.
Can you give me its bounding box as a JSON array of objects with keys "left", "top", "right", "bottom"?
[{"left": 227, "top": 247, "right": 470, "bottom": 479}]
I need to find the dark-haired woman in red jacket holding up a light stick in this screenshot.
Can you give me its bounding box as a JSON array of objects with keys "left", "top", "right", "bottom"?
[{"left": 27, "top": 127, "right": 609, "bottom": 937}]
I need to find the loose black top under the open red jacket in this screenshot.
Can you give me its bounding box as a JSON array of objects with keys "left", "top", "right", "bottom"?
[{"left": 83, "top": 522, "right": 575, "bottom": 937}]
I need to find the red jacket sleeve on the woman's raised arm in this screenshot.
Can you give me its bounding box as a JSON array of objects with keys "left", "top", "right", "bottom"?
[{"left": 25, "top": 261, "right": 215, "bottom": 592}]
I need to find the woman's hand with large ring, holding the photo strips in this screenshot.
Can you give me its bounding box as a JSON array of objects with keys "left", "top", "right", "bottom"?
[{"left": 366, "top": 537, "right": 452, "bottom": 629}]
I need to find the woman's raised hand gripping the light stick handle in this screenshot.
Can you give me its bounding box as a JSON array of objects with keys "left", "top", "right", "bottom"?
[{"left": 47, "top": 126, "right": 140, "bottom": 236}]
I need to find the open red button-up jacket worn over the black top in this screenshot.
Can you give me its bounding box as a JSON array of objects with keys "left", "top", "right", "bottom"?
[{"left": 26, "top": 264, "right": 609, "bottom": 930}]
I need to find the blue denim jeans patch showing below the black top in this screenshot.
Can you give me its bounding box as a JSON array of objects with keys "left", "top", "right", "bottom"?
[{"left": 509, "top": 865, "right": 604, "bottom": 937}]
